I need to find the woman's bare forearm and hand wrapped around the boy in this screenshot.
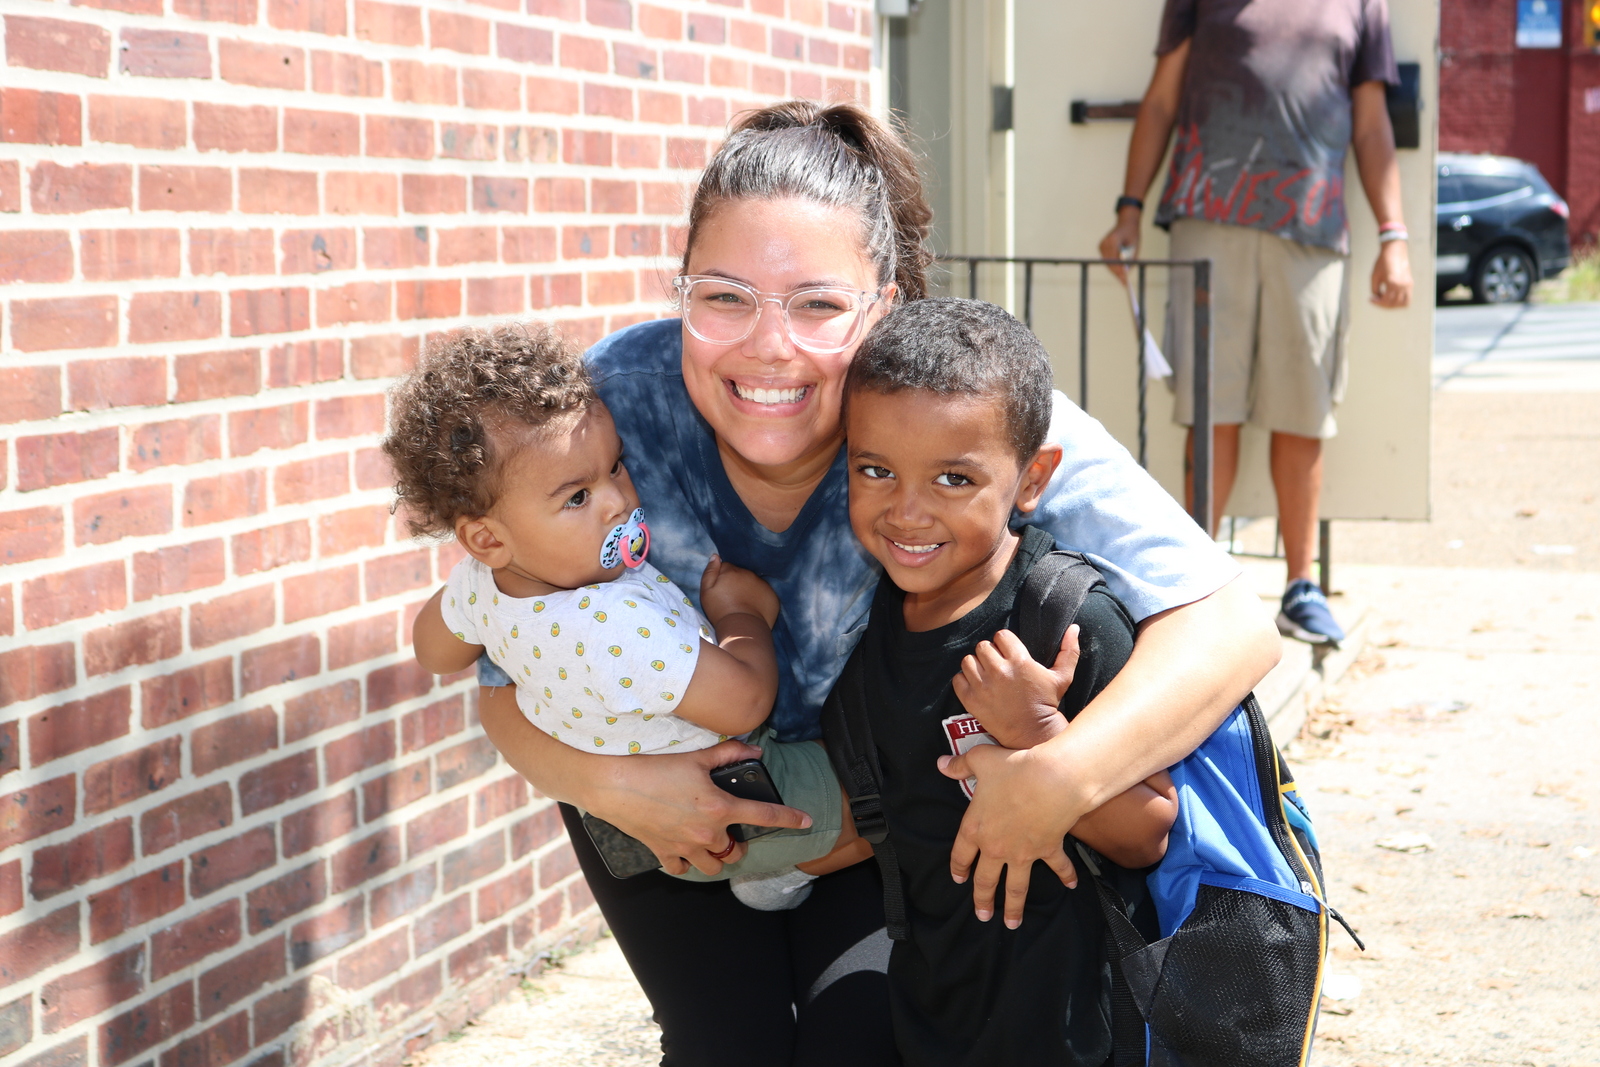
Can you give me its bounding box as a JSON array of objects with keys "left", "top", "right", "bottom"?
[{"left": 941, "top": 579, "right": 1283, "bottom": 923}]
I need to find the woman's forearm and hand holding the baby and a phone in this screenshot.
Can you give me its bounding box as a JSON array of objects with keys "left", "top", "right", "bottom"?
[{"left": 478, "top": 686, "right": 811, "bottom": 875}]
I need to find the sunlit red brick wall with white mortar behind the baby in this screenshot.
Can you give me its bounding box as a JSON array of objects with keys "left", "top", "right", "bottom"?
[{"left": 0, "top": 0, "right": 870, "bottom": 1067}]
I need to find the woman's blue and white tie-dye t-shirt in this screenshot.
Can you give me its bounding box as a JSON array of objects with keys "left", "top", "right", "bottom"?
[{"left": 478, "top": 318, "right": 1238, "bottom": 741}]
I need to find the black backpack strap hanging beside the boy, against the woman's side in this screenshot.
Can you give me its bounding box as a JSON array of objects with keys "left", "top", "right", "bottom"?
[{"left": 822, "top": 646, "right": 910, "bottom": 941}]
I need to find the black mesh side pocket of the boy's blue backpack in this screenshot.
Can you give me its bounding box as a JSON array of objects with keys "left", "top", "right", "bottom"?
[{"left": 1122, "top": 885, "right": 1323, "bottom": 1067}]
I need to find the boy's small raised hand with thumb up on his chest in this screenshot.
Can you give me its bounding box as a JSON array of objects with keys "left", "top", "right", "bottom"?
[{"left": 950, "top": 624, "right": 1078, "bottom": 749}]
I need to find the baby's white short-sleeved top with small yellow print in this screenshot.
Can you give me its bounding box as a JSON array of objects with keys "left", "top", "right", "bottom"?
[{"left": 440, "top": 557, "right": 726, "bottom": 755}]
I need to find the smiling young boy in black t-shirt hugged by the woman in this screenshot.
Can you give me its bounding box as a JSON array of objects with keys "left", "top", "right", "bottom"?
[{"left": 837, "top": 299, "right": 1176, "bottom": 1067}]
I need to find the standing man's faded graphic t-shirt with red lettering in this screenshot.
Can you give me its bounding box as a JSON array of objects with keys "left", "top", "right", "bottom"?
[{"left": 1155, "top": 0, "right": 1400, "bottom": 253}]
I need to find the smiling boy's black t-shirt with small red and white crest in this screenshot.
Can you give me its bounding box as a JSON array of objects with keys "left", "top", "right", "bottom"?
[{"left": 861, "top": 526, "right": 1134, "bottom": 1067}]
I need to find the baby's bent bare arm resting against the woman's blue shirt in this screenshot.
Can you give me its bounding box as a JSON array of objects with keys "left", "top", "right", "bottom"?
[{"left": 674, "top": 557, "right": 778, "bottom": 736}]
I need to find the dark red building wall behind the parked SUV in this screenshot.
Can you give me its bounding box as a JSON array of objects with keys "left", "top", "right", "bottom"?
[{"left": 1438, "top": 0, "right": 1600, "bottom": 245}]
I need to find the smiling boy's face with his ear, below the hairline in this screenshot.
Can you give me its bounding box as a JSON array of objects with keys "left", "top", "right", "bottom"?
[{"left": 846, "top": 389, "right": 1061, "bottom": 630}]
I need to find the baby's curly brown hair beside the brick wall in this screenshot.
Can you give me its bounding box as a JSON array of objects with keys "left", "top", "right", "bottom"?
[{"left": 384, "top": 326, "right": 597, "bottom": 536}]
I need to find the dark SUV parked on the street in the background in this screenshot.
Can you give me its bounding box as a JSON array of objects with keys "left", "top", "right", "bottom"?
[{"left": 1434, "top": 154, "right": 1573, "bottom": 304}]
